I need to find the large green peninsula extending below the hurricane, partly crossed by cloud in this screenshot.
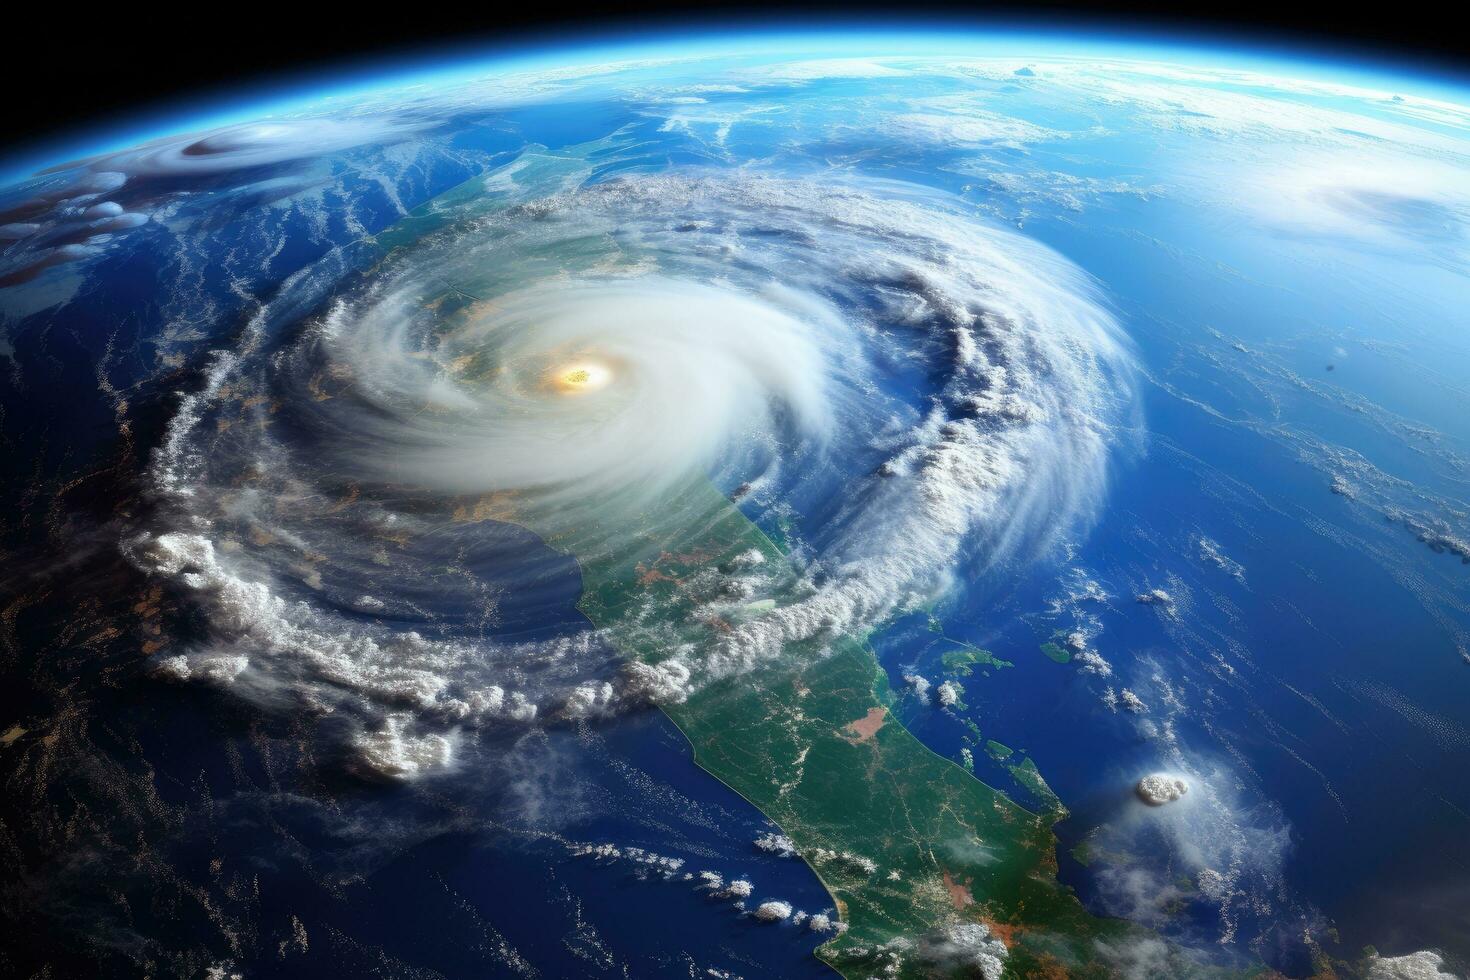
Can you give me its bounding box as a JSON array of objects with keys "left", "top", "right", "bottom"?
[{"left": 535, "top": 480, "right": 1133, "bottom": 977}]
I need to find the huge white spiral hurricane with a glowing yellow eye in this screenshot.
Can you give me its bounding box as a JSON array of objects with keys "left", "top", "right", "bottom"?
[{"left": 128, "top": 170, "right": 1133, "bottom": 777}]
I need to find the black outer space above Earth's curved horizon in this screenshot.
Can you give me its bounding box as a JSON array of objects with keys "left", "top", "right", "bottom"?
[{"left": 0, "top": 0, "right": 1470, "bottom": 156}]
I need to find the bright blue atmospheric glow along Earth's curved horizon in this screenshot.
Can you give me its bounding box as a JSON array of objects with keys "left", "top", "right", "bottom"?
[{"left": 0, "top": 19, "right": 1467, "bottom": 185}]
